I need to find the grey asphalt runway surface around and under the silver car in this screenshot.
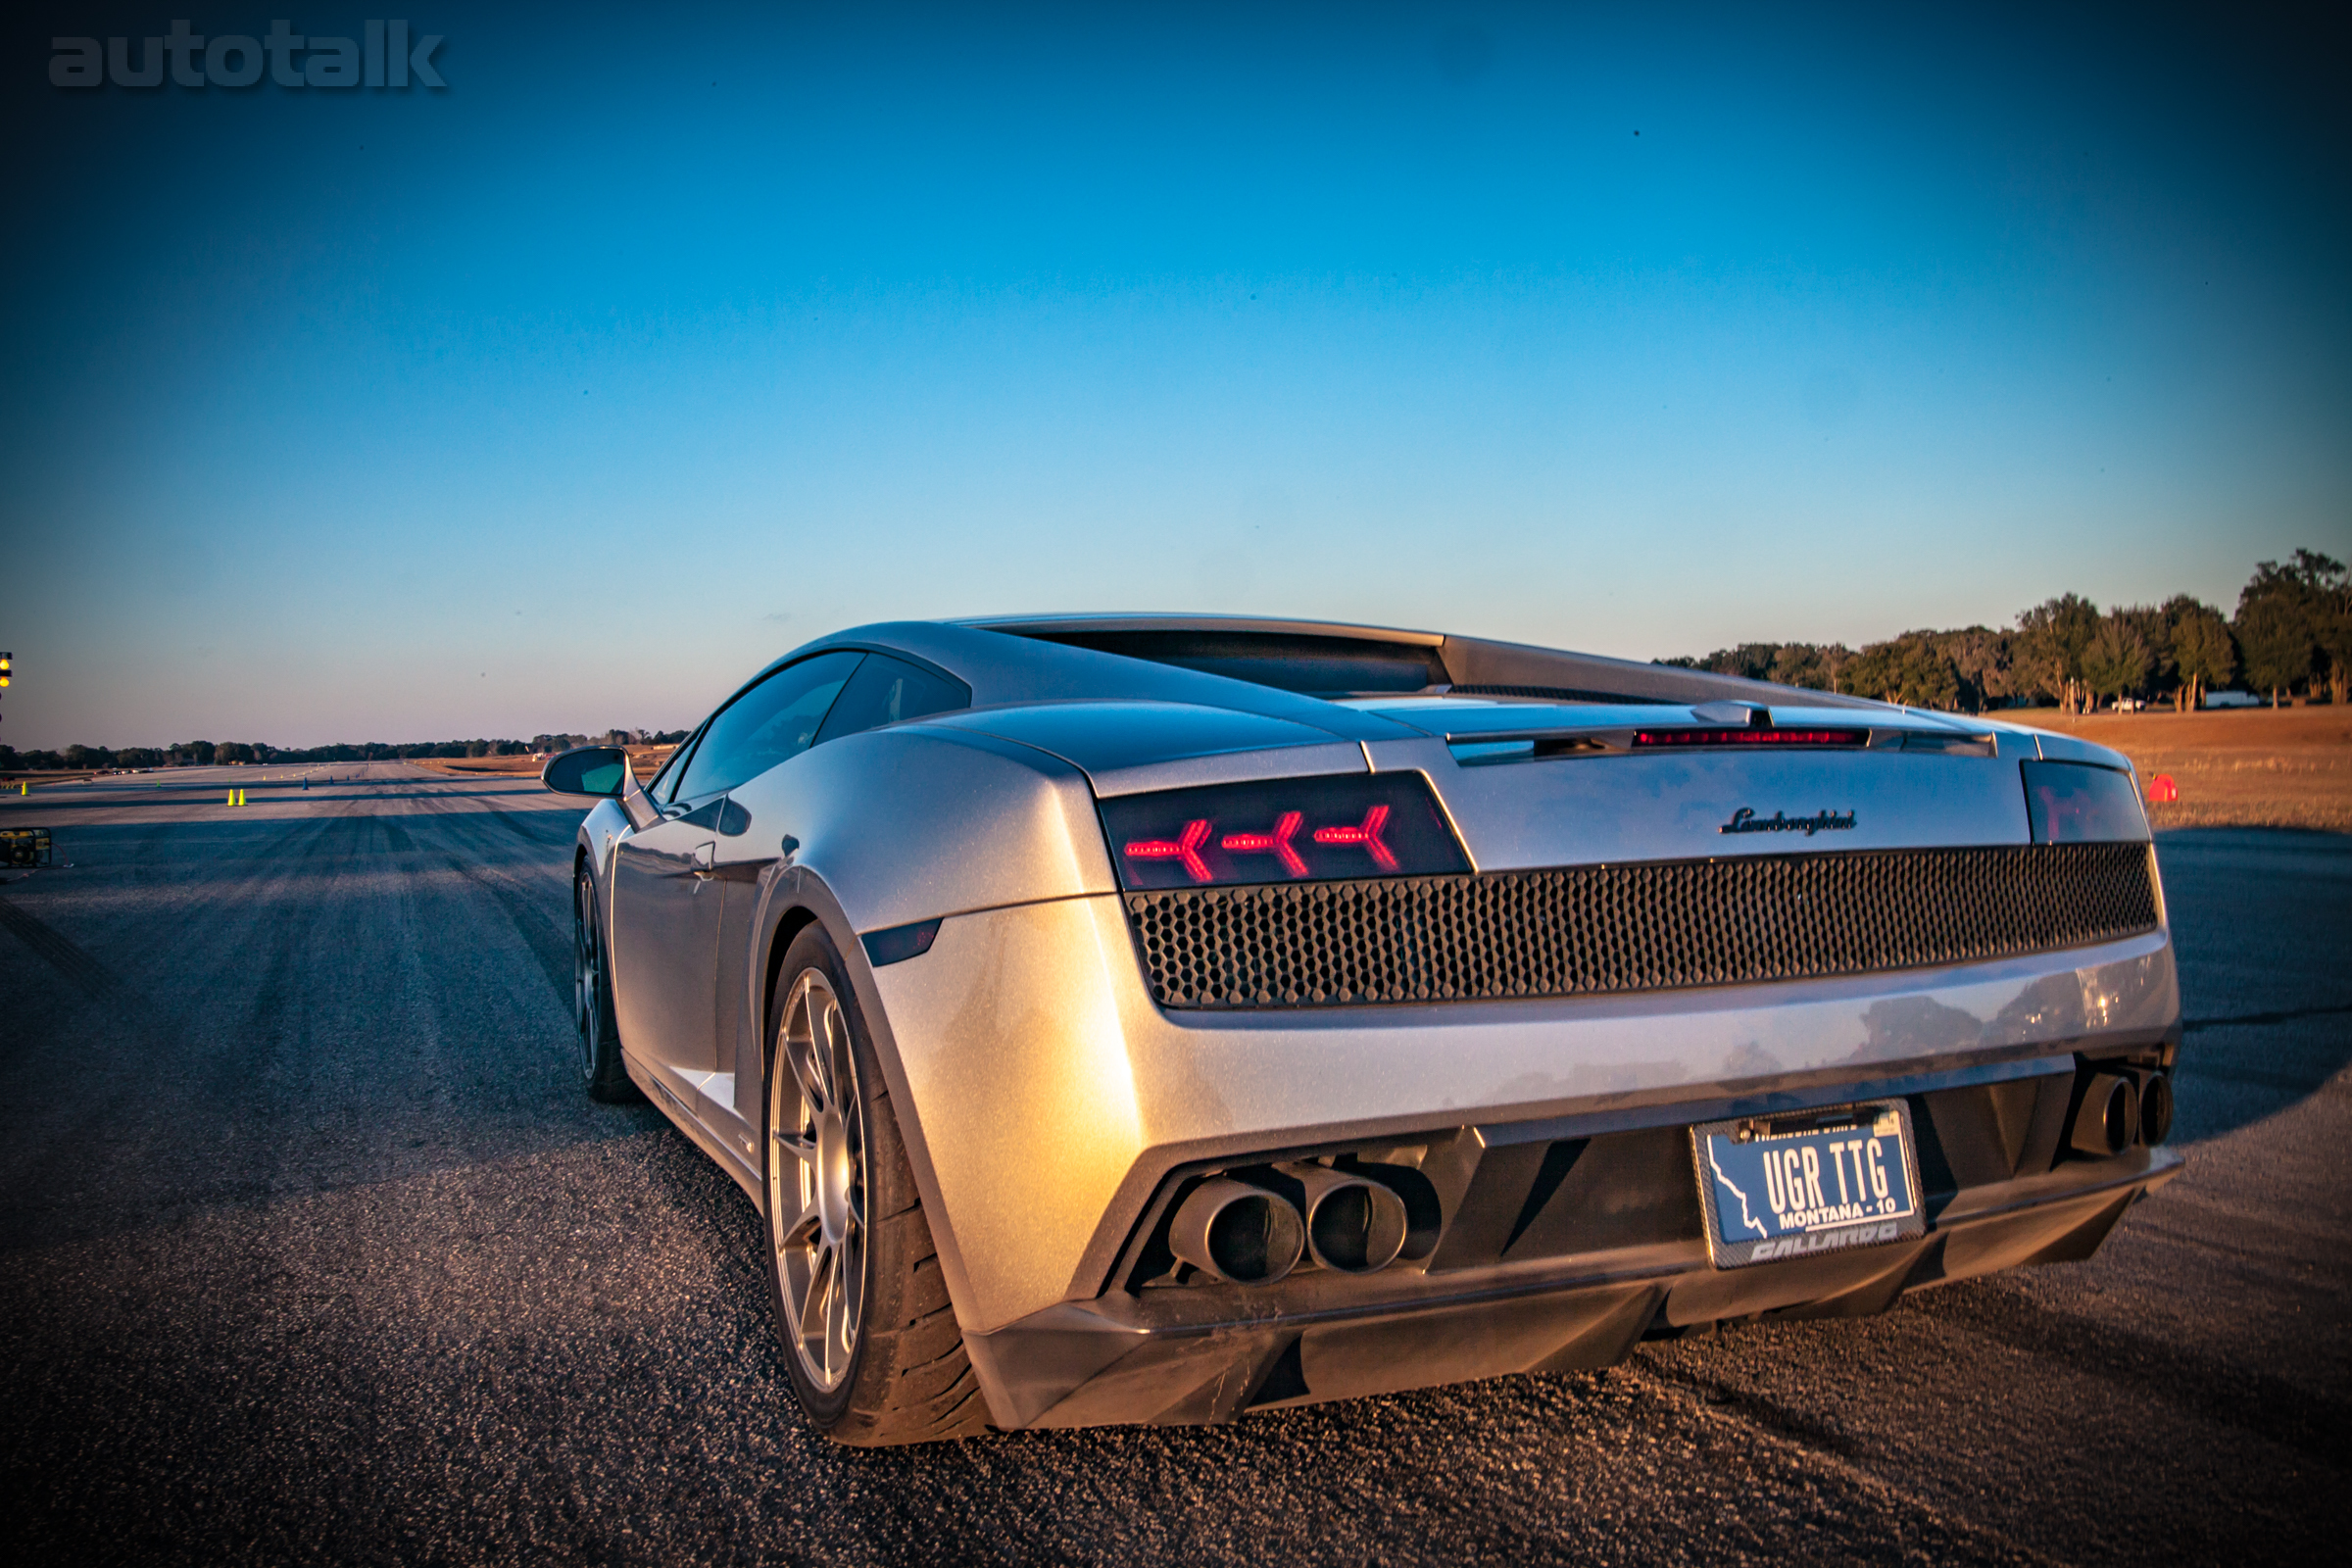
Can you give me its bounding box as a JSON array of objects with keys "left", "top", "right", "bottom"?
[{"left": 0, "top": 764, "right": 2352, "bottom": 1563}]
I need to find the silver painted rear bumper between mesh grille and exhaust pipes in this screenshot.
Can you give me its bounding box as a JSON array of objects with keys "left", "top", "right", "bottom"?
[{"left": 858, "top": 896, "right": 2180, "bottom": 1338}]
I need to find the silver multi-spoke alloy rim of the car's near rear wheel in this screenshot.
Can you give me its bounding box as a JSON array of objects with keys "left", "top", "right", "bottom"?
[{"left": 766, "top": 968, "right": 865, "bottom": 1394}]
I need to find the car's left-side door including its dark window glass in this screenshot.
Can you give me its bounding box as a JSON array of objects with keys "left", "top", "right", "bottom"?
[{"left": 612, "top": 651, "right": 863, "bottom": 1074}]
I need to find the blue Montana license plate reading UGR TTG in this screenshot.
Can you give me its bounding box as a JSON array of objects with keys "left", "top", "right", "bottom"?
[{"left": 1691, "top": 1101, "right": 1927, "bottom": 1269}]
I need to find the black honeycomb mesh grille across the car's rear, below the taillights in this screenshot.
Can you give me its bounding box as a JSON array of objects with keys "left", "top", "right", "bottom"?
[{"left": 1127, "top": 844, "right": 2157, "bottom": 1008}]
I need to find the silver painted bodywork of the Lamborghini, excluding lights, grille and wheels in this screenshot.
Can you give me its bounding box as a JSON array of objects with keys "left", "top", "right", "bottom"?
[{"left": 578, "top": 615, "right": 2180, "bottom": 1425}]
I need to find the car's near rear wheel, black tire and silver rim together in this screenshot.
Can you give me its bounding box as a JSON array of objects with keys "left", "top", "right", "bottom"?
[{"left": 760, "top": 926, "right": 988, "bottom": 1448}]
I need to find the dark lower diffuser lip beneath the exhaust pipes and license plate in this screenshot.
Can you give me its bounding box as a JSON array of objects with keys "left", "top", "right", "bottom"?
[{"left": 964, "top": 1148, "right": 2180, "bottom": 1427}]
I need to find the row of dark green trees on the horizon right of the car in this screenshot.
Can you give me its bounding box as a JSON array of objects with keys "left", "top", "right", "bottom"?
[{"left": 1658, "top": 550, "right": 2352, "bottom": 712}]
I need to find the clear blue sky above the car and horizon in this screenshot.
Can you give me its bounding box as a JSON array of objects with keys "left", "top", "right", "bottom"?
[{"left": 0, "top": 0, "right": 2352, "bottom": 750}]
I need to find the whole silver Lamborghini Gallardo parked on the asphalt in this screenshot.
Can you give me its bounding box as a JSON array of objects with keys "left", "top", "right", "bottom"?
[{"left": 546, "top": 615, "right": 2180, "bottom": 1444}]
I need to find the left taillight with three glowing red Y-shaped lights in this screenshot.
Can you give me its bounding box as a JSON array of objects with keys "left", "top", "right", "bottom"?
[{"left": 1101, "top": 773, "right": 1470, "bottom": 889}]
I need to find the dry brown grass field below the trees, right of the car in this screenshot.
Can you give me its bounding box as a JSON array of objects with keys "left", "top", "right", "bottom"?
[{"left": 2023, "top": 708, "right": 2352, "bottom": 832}]
